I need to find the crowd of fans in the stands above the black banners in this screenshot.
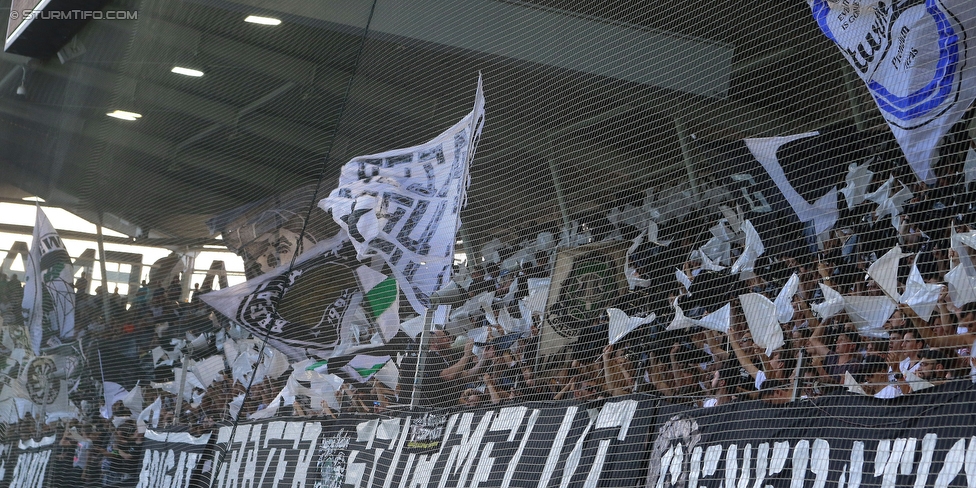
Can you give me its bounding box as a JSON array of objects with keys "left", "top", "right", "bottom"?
[{"left": 0, "top": 129, "right": 976, "bottom": 486}]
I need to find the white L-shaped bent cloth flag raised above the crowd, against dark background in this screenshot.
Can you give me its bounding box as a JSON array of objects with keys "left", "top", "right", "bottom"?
[{"left": 743, "top": 132, "right": 839, "bottom": 234}]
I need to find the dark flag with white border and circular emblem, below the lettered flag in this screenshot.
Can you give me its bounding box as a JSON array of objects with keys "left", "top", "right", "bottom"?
[{"left": 200, "top": 236, "right": 386, "bottom": 362}]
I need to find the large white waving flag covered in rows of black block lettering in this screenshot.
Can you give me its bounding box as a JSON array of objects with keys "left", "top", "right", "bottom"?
[{"left": 319, "top": 77, "right": 485, "bottom": 314}]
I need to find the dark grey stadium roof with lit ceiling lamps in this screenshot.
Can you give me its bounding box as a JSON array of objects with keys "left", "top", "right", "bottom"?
[{"left": 0, "top": 0, "right": 876, "bottom": 252}]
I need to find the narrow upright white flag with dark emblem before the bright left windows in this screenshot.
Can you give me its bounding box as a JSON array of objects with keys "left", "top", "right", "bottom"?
[{"left": 21, "top": 207, "right": 75, "bottom": 356}]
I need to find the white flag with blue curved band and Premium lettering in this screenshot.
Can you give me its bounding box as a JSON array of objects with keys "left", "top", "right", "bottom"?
[{"left": 807, "top": 0, "right": 976, "bottom": 184}]
